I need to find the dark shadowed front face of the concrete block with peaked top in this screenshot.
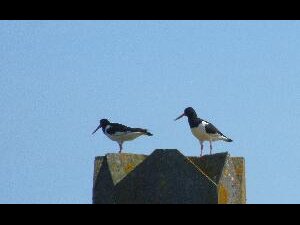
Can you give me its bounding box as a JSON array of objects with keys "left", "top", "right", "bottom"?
[{"left": 115, "top": 149, "right": 218, "bottom": 204}]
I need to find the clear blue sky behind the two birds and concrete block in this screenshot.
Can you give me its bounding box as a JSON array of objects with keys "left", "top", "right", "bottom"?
[{"left": 0, "top": 21, "right": 300, "bottom": 203}]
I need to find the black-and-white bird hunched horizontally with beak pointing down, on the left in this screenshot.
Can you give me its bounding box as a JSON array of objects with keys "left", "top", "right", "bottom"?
[{"left": 92, "top": 119, "right": 153, "bottom": 153}]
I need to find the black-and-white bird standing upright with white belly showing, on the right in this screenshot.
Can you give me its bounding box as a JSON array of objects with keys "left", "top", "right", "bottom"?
[{"left": 175, "top": 107, "right": 233, "bottom": 156}]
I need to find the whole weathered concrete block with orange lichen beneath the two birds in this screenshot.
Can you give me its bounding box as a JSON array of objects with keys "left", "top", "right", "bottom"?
[{"left": 93, "top": 149, "right": 246, "bottom": 204}]
